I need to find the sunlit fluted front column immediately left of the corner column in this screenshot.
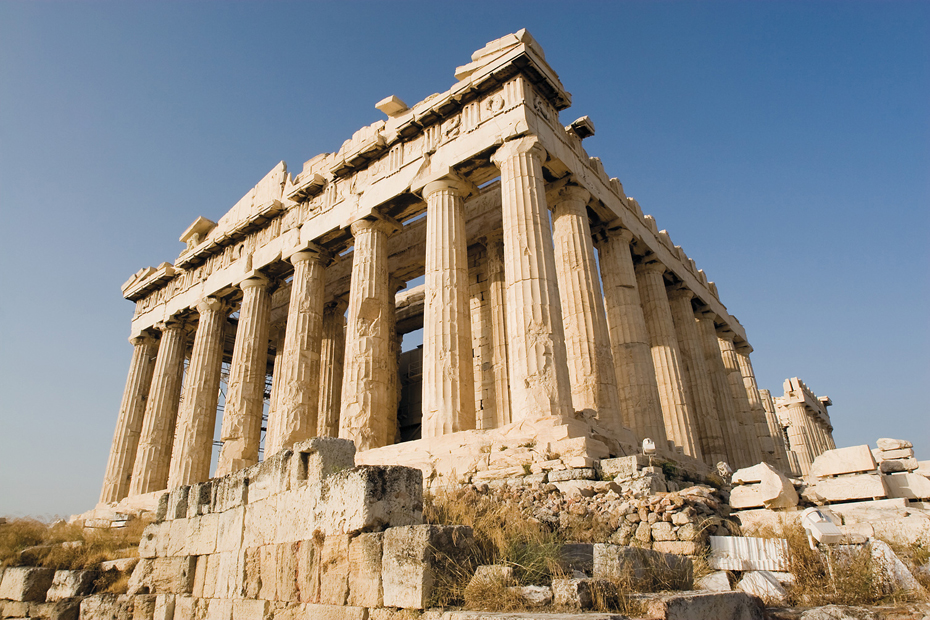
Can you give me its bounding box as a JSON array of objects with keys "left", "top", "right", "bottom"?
[{"left": 422, "top": 176, "right": 475, "bottom": 438}]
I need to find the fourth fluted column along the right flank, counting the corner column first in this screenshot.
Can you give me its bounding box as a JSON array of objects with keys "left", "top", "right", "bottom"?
[{"left": 636, "top": 260, "right": 703, "bottom": 459}]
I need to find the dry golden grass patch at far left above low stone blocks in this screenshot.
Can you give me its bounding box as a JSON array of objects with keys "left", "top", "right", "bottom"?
[{"left": 0, "top": 519, "right": 148, "bottom": 568}]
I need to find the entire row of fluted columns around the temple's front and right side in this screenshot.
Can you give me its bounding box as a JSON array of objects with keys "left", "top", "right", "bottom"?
[{"left": 101, "top": 137, "right": 784, "bottom": 501}]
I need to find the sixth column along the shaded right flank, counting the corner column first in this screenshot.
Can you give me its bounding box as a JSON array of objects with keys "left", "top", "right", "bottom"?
[{"left": 695, "top": 311, "right": 751, "bottom": 469}]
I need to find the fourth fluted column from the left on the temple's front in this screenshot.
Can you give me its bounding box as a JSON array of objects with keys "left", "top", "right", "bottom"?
[{"left": 216, "top": 275, "right": 271, "bottom": 477}]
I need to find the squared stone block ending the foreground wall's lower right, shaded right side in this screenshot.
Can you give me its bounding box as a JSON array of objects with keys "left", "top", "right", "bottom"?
[{"left": 381, "top": 525, "right": 472, "bottom": 609}]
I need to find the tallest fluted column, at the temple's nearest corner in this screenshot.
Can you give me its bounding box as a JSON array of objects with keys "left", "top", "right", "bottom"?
[{"left": 491, "top": 137, "right": 572, "bottom": 421}]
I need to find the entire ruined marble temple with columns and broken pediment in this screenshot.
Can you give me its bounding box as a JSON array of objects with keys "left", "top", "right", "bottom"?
[{"left": 101, "top": 30, "right": 784, "bottom": 502}]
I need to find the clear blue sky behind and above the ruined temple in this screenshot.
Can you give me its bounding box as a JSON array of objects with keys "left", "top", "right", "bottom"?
[{"left": 0, "top": 0, "right": 930, "bottom": 516}]
